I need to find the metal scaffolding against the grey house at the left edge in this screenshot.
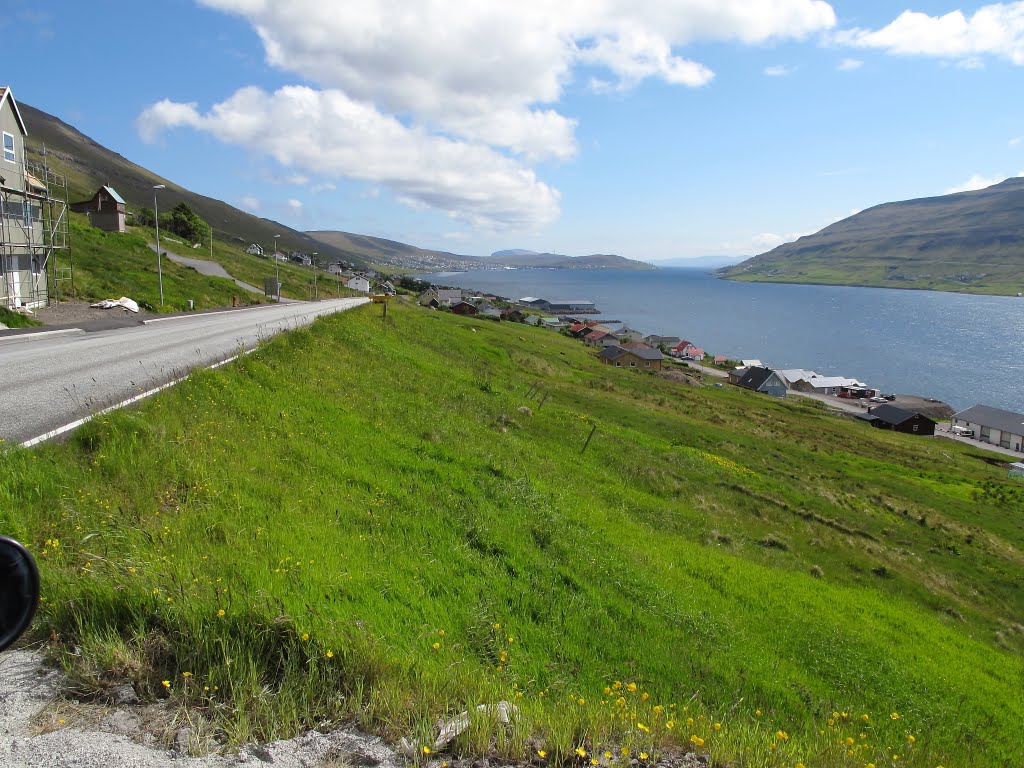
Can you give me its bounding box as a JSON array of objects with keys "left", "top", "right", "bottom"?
[{"left": 0, "top": 147, "right": 69, "bottom": 309}]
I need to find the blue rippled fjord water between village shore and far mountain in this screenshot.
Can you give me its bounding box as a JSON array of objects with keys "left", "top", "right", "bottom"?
[{"left": 423, "top": 268, "right": 1024, "bottom": 413}]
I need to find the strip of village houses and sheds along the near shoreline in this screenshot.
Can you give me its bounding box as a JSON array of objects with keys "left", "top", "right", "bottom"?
[{"left": 418, "top": 286, "right": 1024, "bottom": 462}]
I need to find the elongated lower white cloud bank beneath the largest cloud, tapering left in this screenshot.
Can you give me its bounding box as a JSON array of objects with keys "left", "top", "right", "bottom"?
[{"left": 138, "top": 86, "right": 559, "bottom": 229}]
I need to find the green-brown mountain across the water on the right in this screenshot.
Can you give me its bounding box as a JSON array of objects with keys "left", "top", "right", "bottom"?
[{"left": 720, "top": 178, "right": 1024, "bottom": 294}]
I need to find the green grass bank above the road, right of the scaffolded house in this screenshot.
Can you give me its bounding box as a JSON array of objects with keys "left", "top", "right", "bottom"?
[{"left": 61, "top": 214, "right": 264, "bottom": 312}]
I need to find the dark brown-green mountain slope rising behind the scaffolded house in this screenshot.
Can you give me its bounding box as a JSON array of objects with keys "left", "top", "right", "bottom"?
[{"left": 18, "top": 102, "right": 369, "bottom": 264}]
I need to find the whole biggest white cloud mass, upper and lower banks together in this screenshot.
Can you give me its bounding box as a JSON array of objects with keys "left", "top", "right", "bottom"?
[{"left": 149, "top": 0, "right": 836, "bottom": 228}]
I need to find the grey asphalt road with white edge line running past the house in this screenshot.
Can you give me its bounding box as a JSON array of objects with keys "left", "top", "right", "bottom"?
[{"left": 0, "top": 298, "right": 369, "bottom": 442}]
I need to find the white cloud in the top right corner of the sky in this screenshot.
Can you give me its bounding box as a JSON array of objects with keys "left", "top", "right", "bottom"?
[{"left": 836, "top": 2, "right": 1024, "bottom": 66}]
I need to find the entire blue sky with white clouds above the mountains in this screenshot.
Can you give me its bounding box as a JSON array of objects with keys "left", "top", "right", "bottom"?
[{"left": 8, "top": 0, "right": 1024, "bottom": 262}]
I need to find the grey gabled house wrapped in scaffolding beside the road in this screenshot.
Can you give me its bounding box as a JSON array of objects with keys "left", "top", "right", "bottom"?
[{"left": 0, "top": 86, "right": 71, "bottom": 309}]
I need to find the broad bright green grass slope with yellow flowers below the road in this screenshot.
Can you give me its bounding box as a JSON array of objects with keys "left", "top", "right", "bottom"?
[{"left": 0, "top": 305, "right": 1024, "bottom": 768}]
